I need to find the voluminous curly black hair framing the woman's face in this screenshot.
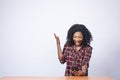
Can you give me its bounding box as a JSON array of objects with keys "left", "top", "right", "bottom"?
[{"left": 66, "top": 24, "right": 92, "bottom": 47}]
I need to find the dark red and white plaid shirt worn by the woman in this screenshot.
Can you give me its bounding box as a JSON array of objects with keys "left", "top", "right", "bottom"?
[{"left": 60, "top": 46, "right": 92, "bottom": 76}]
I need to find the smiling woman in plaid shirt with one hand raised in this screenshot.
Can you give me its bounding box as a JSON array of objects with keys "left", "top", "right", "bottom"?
[{"left": 54, "top": 24, "right": 92, "bottom": 76}]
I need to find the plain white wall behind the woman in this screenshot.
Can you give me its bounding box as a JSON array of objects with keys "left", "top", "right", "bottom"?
[{"left": 0, "top": 0, "right": 120, "bottom": 79}]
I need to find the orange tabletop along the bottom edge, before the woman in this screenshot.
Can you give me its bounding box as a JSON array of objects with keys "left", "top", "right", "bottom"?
[{"left": 0, "top": 76, "right": 113, "bottom": 80}]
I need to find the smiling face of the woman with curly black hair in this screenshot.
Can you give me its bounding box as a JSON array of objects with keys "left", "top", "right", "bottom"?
[{"left": 73, "top": 32, "right": 83, "bottom": 46}]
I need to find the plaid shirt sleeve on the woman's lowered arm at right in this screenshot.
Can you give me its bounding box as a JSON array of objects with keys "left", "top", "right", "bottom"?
[{"left": 82, "top": 46, "right": 93, "bottom": 67}]
